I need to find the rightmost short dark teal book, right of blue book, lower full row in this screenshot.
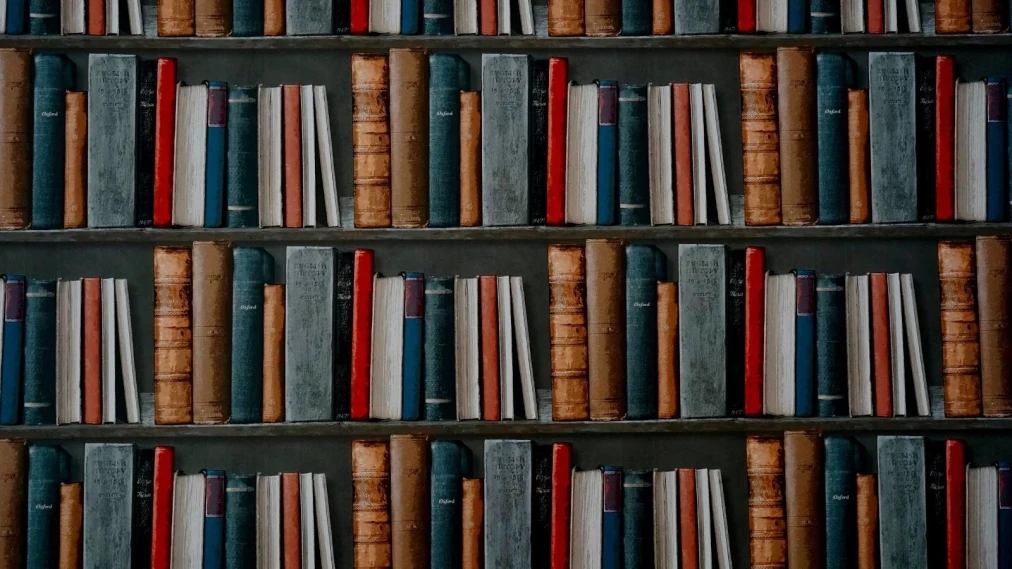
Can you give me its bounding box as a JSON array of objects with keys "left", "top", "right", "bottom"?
[{"left": 816, "top": 273, "right": 848, "bottom": 417}]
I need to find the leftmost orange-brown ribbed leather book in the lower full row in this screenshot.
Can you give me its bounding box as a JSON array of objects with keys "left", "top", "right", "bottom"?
[{"left": 154, "top": 247, "right": 193, "bottom": 424}]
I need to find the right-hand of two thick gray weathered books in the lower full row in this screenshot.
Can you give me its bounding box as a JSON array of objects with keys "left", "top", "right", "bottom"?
[{"left": 678, "top": 245, "right": 728, "bottom": 418}]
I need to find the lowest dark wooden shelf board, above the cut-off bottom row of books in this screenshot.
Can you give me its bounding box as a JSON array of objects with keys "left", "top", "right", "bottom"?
[{"left": 0, "top": 417, "right": 1012, "bottom": 441}]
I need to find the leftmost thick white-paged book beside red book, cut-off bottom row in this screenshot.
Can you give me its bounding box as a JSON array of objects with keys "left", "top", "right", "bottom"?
[{"left": 169, "top": 472, "right": 204, "bottom": 569}]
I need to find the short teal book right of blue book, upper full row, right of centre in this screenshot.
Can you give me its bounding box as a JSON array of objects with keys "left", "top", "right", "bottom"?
[{"left": 618, "top": 85, "right": 650, "bottom": 225}]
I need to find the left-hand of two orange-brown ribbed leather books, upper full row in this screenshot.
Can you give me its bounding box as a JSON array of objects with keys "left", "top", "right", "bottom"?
[{"left": 351, "top": 54, "right": 391, "bottom": 227}]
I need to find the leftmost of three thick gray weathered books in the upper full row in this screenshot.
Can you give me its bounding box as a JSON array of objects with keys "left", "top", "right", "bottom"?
[{"left": 88, "top": 54, "right": 138, "bottom": 227}]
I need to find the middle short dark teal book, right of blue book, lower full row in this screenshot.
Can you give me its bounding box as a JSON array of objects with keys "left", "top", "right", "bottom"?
[{"left": 423, "top": 276, "right": 456, "bottom": 421}]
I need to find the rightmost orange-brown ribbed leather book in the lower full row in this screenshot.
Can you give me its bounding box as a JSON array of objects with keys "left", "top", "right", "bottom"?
[{"left": 938, "top": 241, "right": 983, "bottom": 417}]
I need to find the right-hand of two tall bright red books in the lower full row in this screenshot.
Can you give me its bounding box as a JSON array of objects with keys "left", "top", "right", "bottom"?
[{"left": 745, "top": 247, "right": 766, "bottom": 417}]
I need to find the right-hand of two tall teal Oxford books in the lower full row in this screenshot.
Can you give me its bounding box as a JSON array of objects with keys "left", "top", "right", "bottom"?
[{"left": 625, "top": 245, "right": 657, "bottom": 419}]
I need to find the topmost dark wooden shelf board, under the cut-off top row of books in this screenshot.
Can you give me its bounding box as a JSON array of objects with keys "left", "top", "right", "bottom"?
[{"left": 0, "top": 33, "right": 1012, "bottom": 52}]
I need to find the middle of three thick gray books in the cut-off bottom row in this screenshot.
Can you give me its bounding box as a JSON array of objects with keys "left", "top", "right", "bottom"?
[{"left": 485, "top": 440, "right": 531, "bottom": 569}]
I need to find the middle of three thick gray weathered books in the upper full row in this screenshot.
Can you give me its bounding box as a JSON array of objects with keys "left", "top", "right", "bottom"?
[{"left": 482, "top": 54, "right": 530, "bottom": 226}]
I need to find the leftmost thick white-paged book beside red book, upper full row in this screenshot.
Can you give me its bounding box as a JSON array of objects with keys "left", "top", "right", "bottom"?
[{"left": 172, "top": 83, "right": 207, "bottom": 227}]
